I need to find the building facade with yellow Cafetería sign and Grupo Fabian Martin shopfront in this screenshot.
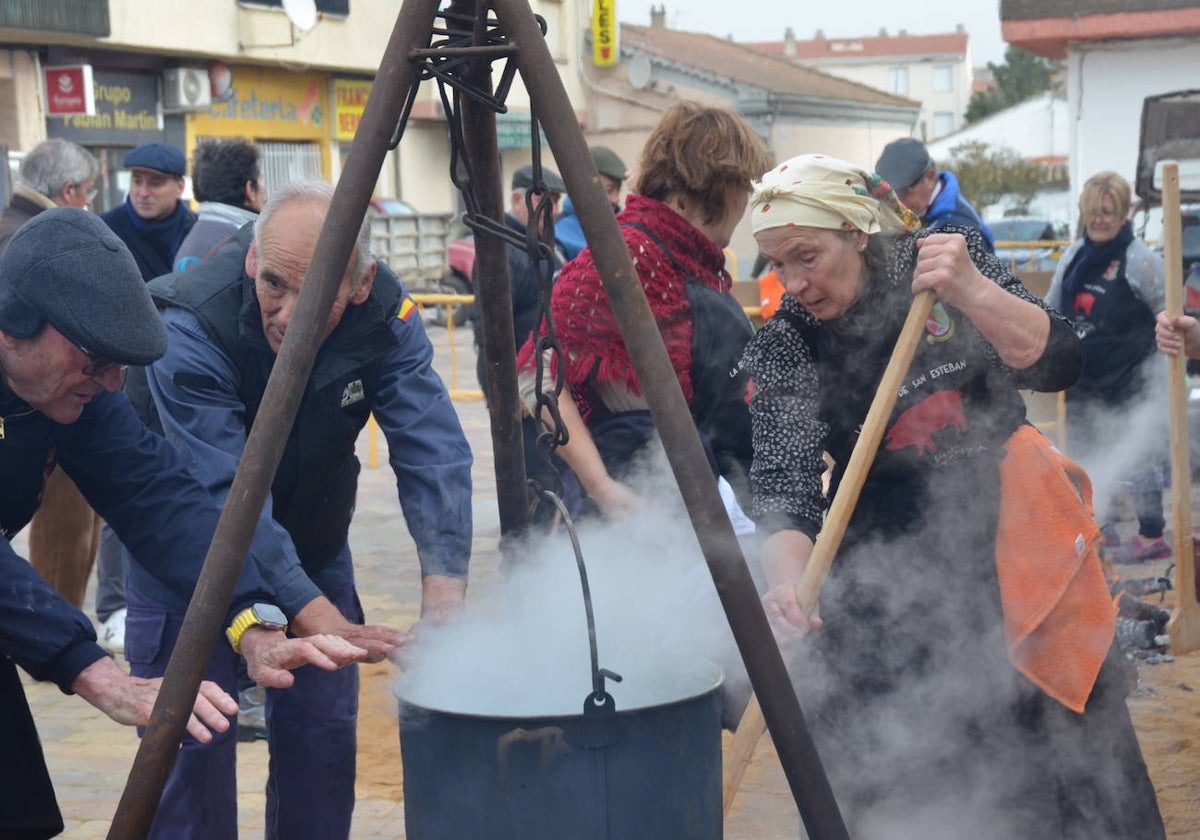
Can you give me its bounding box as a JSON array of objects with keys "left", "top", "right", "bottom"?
[{"left": 0, "top": 0, "right": 581, "bottom": 219}]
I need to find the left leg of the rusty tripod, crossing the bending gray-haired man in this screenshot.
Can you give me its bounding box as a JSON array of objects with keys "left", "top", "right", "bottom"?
[{"left": 108, "top": 0, "right": 438, "bottom": 840}]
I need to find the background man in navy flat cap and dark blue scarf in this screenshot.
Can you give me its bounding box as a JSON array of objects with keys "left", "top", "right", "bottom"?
[{"left": 101, "top": 143, "right": 196, "bottom": 281}]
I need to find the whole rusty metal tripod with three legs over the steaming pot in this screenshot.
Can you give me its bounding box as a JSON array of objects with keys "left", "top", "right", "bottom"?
[{"left": 108, "top": 0, "right": 848, "bottom": 840}]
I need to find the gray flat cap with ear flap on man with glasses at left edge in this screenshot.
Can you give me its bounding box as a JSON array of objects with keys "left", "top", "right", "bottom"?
[{"left": 0, "top": 208, "right": 167, "bottom": 365}]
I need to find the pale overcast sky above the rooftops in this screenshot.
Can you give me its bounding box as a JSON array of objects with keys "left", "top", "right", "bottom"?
[{"left": 616, "top": 0, "right": 1004, "bottom": 66}]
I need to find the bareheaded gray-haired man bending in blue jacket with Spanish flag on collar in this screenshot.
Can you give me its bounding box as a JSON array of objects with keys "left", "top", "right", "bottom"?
[{"left": 138, "top": 181, "right": 472, "bottom": 840}]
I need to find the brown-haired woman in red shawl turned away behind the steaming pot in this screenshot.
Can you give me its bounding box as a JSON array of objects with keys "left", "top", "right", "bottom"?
[{"left": 518, "top": 102, "right": 770, "bottom": 514}]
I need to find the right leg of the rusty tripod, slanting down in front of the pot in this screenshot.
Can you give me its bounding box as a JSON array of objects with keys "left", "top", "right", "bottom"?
[{"left": 494, "top": 0, "right": 848, "bottom": 840}]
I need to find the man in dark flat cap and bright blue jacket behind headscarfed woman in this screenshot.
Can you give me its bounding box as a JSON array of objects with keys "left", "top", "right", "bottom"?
[{"left": 875, "top": 137, "right": 996, "bottom": 251}]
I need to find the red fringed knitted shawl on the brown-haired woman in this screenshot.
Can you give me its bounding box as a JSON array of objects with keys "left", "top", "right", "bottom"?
[{"left": 517, "top": 196, "right": 731, "bottom": 419}]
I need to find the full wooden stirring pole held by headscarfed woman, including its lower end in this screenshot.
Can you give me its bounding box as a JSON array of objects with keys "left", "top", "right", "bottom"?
[{"left": 722, "top": 290, "right": 935, "bottom": 814}]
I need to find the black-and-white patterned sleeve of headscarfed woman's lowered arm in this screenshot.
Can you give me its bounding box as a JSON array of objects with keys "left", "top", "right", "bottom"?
[{"left": 743, "top": 295, "right": 828, "bottom": 540}]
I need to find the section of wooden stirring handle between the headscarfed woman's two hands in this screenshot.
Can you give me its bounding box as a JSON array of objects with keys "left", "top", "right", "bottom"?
[{"left": 796, "top": 289, "right": 936, "bottom": 616}]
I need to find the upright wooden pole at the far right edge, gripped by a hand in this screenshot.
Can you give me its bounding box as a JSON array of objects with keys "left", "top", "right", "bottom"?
[{"left": 1163, "top": 163, "right": 1200, "bottom": 655}]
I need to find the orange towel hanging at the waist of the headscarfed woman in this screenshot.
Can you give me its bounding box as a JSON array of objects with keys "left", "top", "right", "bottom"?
[{"left": 996, "top": 426, "right": 1117, "bottom": 713}]
